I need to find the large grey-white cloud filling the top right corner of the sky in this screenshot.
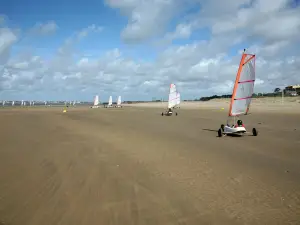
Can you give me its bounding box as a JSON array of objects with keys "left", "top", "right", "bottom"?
[{"left": 205, "top": 0, "right": 300, "bottom": 46}]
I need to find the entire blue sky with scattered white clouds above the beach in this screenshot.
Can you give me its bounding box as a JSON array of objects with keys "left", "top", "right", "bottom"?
[{"left": 0, "top": 0, "right": 300, "bottom": 101}]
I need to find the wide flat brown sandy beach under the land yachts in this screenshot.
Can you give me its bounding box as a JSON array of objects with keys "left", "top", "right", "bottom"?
[{"left": 0, "top": 102, "right": 300, "bottom": 225}]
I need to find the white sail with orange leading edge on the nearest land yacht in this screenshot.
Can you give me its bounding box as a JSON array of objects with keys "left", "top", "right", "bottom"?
[{"left": 229, "top": 50, "right": 255, "bottom": 116}]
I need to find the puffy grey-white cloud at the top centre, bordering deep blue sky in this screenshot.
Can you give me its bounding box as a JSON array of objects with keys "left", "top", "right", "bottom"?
[{"left": 105, "top": 0, "right": 191, "bottom": 43}]
